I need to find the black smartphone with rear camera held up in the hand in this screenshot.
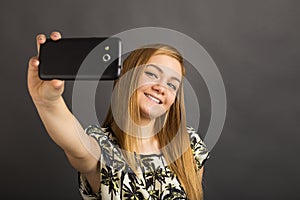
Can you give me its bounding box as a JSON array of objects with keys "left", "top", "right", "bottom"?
[{"left": 39, "top": 37, "right": 122, "bottom": 80}]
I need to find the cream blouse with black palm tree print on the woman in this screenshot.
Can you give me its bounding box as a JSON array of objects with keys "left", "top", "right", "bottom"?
[{"left": 78, "top": 126, "right": 209, "bottom": 200}]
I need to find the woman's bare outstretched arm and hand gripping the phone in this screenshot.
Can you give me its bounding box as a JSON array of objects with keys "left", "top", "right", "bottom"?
[{"left": 28, "top": 32, "right": 100, "bottom": 173}]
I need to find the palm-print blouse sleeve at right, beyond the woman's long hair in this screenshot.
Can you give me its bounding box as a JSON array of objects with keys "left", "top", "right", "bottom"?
[{"left": 187, "top": 126, "right": 209, "bottom": 169}]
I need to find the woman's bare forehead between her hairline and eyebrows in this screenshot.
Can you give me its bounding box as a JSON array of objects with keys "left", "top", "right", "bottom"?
[{"left": 147, "top": 55, "right": 182, "bottom": 76}]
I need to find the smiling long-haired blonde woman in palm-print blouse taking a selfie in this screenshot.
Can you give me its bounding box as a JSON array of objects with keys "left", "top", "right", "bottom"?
[{"left": 28, "top": 32, "right": 208, "bottom": 200}]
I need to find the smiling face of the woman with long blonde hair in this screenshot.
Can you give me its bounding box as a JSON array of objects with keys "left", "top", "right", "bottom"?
[{"left": 137, "top": 55, "right": 182, "bottom": 123}]
